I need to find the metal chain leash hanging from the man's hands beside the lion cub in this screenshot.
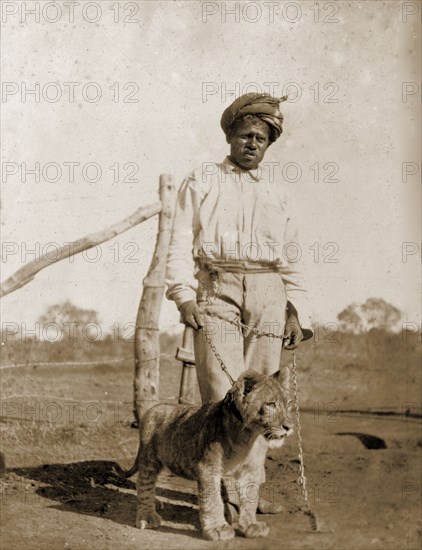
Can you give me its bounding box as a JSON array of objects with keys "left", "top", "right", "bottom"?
[{"left": 204, "top": 314, "right": 319, "bottom": 531}]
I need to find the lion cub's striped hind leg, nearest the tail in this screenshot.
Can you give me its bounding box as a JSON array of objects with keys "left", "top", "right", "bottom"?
[{"left": 136, "top": 456, "right": 161, "bottom": 529}]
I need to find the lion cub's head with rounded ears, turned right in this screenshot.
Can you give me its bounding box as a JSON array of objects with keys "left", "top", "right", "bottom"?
[{"left": 224, "top": 370, "right": 293, "bottom": 447}]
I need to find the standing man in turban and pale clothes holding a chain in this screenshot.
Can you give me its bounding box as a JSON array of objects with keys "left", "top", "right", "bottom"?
[{"left": 167, "top": 93, "right": 312, "bottom": 512}]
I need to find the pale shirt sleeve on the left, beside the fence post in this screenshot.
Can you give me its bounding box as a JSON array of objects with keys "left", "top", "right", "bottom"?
[{"left": 166, "top": 172, "right": 200, "bottom": 308}]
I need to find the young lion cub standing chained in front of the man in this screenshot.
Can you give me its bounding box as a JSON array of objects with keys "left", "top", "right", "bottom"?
[{"left": 126, "top": 370, "right": 292, "bottom": 540}]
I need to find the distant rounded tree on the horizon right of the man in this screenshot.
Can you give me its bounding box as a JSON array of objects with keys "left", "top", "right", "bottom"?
[{"left": 337, "top": 298, "right": 401, "bottom": 333}]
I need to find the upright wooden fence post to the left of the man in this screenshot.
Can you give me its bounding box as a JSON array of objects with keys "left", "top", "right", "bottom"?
[{"left": 134, "top": 174, "right": 176, "bottom": 424}]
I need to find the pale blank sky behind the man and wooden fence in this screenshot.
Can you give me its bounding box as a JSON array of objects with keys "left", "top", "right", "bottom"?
[{"left": 1, "top": 0, "right": 421, "bottom": 338}]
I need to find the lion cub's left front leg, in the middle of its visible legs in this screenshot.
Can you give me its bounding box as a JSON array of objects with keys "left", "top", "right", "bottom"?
[{"left": 198, "top": 467, "right": 235, "bottom": 540}]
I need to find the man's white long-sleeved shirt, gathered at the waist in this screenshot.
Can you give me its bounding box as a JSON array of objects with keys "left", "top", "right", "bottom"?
[{"left": 166, "top": 157, "right": 311, "bottom": 328}]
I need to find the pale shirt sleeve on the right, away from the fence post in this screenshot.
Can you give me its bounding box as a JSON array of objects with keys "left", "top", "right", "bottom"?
[{"left": 281, "top": 196, "right": 312, "bottom": 329}]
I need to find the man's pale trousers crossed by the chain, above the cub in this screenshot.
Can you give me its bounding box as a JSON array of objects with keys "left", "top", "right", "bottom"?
[{"left": 195, "top": 271, "right": 287, "bottom": 402}]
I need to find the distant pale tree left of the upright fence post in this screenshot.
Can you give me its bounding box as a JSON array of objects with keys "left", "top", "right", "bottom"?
[{"left": 38, "top": 300, "right": 102, "bottom": 342}]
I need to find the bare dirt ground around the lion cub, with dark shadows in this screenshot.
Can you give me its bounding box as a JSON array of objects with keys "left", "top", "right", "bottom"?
[{"left": 0, "top": 342, "right": 422, "bottom": 550}]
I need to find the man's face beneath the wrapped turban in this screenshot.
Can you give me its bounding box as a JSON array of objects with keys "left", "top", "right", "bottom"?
[{"left": 230, "top": 120, "right": 270, "bottom": 170}]
